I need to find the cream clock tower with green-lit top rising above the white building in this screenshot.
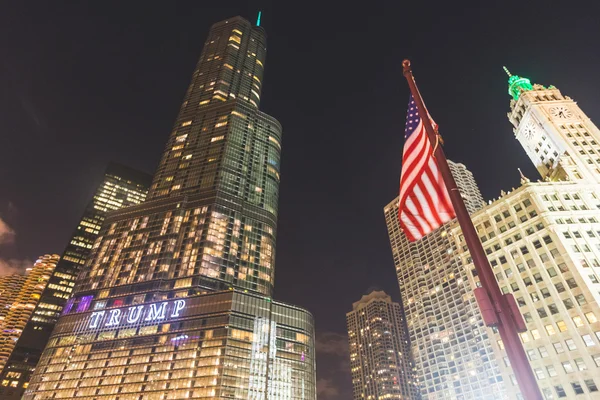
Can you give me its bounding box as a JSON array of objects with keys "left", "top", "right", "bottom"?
[{"left": 504, "top": 68, "right": 600, "bottom": 183}]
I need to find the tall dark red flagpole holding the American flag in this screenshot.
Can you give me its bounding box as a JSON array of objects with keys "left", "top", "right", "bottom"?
[{"left": 402, "top": 60, "right": 542, "bottom": 400}]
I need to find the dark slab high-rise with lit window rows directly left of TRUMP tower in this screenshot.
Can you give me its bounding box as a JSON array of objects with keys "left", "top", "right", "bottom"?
[{"left": 0, "top": 163, "right": 152, "bottom": 400}]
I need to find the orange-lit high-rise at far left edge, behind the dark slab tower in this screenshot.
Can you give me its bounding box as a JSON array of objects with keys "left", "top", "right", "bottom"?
[{"left": 0, "top": 254, "right": 60, "bottom": 374}]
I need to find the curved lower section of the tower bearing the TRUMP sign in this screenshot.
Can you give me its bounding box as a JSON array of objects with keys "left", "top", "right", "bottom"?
[{"left": 25, "top": 291, "right": 316, "bottom": 400}]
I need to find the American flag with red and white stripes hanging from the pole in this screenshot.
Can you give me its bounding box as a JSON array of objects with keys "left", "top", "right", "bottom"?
[{"left": 398, "top": 95, "right": 455, "bottom": 242}]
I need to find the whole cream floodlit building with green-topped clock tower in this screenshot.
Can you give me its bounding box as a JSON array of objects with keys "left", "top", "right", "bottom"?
[{"left": 449, "top": 72, "right": 600, "bottom": 399}]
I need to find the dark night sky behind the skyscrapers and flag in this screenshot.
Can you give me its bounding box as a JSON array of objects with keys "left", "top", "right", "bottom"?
[{"left": 0, "top": 0, "right": 600, "bottom": 400}]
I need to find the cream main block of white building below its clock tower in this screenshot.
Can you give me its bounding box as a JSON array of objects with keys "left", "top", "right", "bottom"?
[{"left": 449, "top": 182, "right": 600, "bottom": 400}]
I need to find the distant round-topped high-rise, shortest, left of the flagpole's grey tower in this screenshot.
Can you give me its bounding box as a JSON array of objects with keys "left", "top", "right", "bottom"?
[{"left": 346, "top": 290, "right": 421, "bottom": 400}]
